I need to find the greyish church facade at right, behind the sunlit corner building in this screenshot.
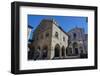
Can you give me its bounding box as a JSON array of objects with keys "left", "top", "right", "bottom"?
[{"left": 67, "top": 27, "right": 88, "bottom": 58}]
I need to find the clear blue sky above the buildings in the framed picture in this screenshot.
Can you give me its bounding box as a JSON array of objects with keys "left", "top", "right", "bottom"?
[{"left": 28, "top": 15, "right": 88, "bottom": 39}]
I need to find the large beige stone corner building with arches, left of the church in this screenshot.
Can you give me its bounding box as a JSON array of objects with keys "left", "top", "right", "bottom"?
[{"left": 32, "top": 19, "right": 68, "bottom": 59}]
